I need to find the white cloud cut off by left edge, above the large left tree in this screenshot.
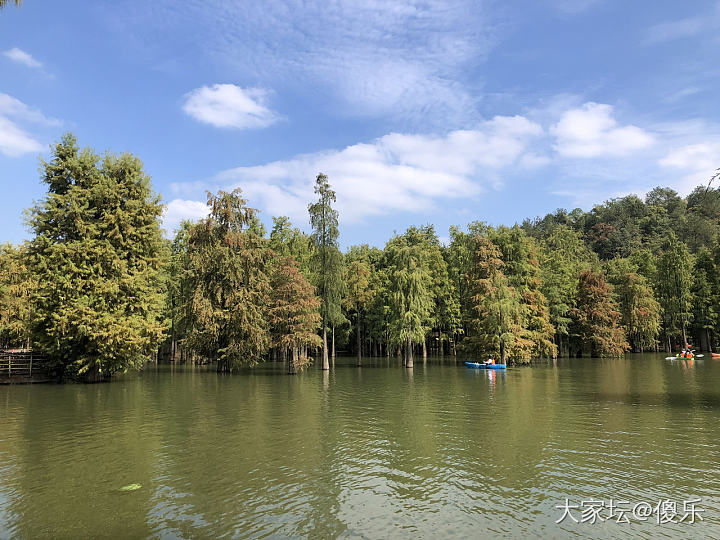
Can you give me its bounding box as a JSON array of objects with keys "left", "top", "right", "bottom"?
[{"left": 0, "top": 93, "right": 60, "bottom": 157}]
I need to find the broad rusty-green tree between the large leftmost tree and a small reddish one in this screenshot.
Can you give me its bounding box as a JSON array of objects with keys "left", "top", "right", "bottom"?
[{"left": 186, "top": 189, "right": 271, "bottom": 371}]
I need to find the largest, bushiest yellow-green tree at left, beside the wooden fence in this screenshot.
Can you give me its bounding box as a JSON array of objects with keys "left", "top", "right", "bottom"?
[{"left": 29, "top": 134, "right": 163, "bottom": 380}]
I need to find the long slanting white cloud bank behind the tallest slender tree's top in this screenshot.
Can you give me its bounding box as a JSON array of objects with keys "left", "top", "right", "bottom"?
[{"left": 194, "top": 116, "right": 543, "bottom": 222}]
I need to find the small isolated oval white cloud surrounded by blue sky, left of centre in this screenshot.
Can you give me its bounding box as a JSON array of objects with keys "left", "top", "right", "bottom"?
[{"left": 183, "top": 84, "right": 279, "bottom": 129}]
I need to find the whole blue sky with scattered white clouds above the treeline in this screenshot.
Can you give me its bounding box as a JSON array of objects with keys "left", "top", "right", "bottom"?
[{"left": 0, "top": 0, "right": 720, "bottom": 246}]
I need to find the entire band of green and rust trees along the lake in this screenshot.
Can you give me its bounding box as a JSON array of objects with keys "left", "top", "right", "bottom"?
[{"left": 0, "top": 134, "right": 720, "bottom": 380}]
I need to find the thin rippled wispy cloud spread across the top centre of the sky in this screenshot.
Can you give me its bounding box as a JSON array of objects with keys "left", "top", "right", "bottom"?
[{"left": 114, "top": 0, "right": 498, "bottom": 129}]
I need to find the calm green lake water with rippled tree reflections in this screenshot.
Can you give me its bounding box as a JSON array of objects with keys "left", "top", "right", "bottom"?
[{"left": 0, "top": 355, "right": 720, "bottom": 538}]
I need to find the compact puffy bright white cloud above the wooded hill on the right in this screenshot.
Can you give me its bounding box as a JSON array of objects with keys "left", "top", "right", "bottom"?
[{"left": 551, "top": 102, "right": 654, "bottom": 158}]
